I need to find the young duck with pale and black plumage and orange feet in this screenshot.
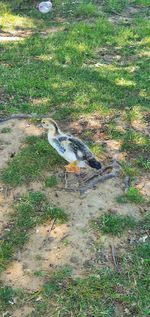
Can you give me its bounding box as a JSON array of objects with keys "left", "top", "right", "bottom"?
[{"left": 41, "top": 118, "right": 102, "bottom": 174}]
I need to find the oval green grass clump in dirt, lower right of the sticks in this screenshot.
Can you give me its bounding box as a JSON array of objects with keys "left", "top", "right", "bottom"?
[{"left": 94, "top": 214, "right": 136, "bottom": 235}]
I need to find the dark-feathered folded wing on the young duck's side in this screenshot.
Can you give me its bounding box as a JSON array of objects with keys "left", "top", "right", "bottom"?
[{"left": 68, "top": 137, "right": 93, "bottom": 161}]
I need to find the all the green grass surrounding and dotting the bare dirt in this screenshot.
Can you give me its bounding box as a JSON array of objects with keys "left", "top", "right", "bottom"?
[{"left": 0, "top": 0, "right": 150, "bottom": 317}]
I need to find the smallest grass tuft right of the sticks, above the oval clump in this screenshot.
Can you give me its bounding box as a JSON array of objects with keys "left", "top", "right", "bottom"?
[{"left": 117, "top": 187, "right": 145, "bottom": 204}]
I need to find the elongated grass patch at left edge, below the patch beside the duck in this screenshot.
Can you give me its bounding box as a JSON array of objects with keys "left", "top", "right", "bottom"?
[{"left": 0, "top": 192, "right": 67, "bottom": 269}]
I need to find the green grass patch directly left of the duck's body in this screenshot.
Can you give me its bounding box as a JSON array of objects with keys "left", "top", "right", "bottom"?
[{"left": 1, "top": 136, "right": 63, "bottom": 186}]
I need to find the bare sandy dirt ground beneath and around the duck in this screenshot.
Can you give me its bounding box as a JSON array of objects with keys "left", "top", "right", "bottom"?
[{"left": 0, "top": 120, "right": 149, "bottom": 308}]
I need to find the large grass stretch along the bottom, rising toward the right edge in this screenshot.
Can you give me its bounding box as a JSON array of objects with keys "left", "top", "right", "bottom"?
[{"left": 19, "top": 238, "right": 150, "bottom": 317}]
